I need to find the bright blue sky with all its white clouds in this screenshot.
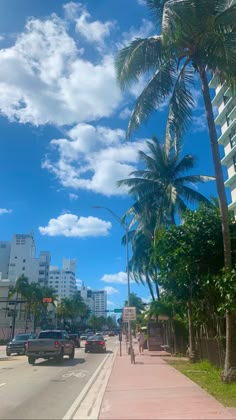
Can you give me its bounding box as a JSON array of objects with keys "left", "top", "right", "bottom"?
[{"left": 0, "top": 0, "right": 229, "bottom": 308}]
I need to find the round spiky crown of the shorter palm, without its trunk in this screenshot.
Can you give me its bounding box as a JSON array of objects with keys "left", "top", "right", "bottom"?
[{"left": 118, "top": 137, "right": 214, "bottom": 226}]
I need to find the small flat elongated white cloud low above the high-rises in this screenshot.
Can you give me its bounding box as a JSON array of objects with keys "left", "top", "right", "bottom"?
[{"left": 39, "top": 214, "right": 111, "bottom": 238}]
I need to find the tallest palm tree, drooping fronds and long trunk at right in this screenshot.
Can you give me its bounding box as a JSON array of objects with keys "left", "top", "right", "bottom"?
[{"left": 116, "top": 0, "right": 236, "bottom": 381}]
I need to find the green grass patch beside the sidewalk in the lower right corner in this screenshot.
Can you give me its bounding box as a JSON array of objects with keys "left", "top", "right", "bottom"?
[{"left": 168, "top": 359, "right": 236, "bottom": 407}]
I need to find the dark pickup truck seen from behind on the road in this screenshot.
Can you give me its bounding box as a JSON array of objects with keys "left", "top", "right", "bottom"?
[{"left": 26, "top": 330, "right": 75, "bottom": 365}]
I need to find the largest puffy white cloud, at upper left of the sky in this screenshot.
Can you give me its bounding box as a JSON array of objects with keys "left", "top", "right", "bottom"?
[{"left": 0, "top": 10, "right": 122, "bottom": 126}]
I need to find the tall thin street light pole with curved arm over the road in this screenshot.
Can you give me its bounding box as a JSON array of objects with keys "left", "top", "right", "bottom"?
[{"left": 93, "top": 206, "right": 133, "bottom": 363}]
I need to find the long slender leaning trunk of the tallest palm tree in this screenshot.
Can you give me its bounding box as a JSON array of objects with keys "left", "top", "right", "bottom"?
[{"left": 198, "top": 65, "right": 236, "bottom": 382}]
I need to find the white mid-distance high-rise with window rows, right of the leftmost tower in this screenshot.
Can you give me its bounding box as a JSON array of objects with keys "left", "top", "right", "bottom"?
[{"left": 48, "top": 259, "right": 77, "bottom": 299}]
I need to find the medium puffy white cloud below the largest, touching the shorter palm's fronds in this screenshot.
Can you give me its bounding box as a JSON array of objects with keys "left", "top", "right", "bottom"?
[{"left": 42, "top": 124, "right": 147, "bottom": 196}]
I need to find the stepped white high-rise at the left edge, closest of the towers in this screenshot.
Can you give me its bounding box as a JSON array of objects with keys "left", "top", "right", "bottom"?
[{"left": 0, "top": 232, "right": 51, "bottom": 285}]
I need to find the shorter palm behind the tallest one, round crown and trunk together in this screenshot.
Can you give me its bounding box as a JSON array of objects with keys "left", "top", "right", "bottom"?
[{"left": 118, "top": 137, "right": 213, "bottom": 300}]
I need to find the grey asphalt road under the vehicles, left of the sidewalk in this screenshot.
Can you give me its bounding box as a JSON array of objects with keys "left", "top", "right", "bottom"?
[{"left": 0, "top": 337, "right": 117, "bottom": 420}]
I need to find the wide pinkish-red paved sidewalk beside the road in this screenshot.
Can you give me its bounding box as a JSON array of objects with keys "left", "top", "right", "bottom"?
[{"left": 99, "top": 345, "right": 236, "bottom": 420}]
